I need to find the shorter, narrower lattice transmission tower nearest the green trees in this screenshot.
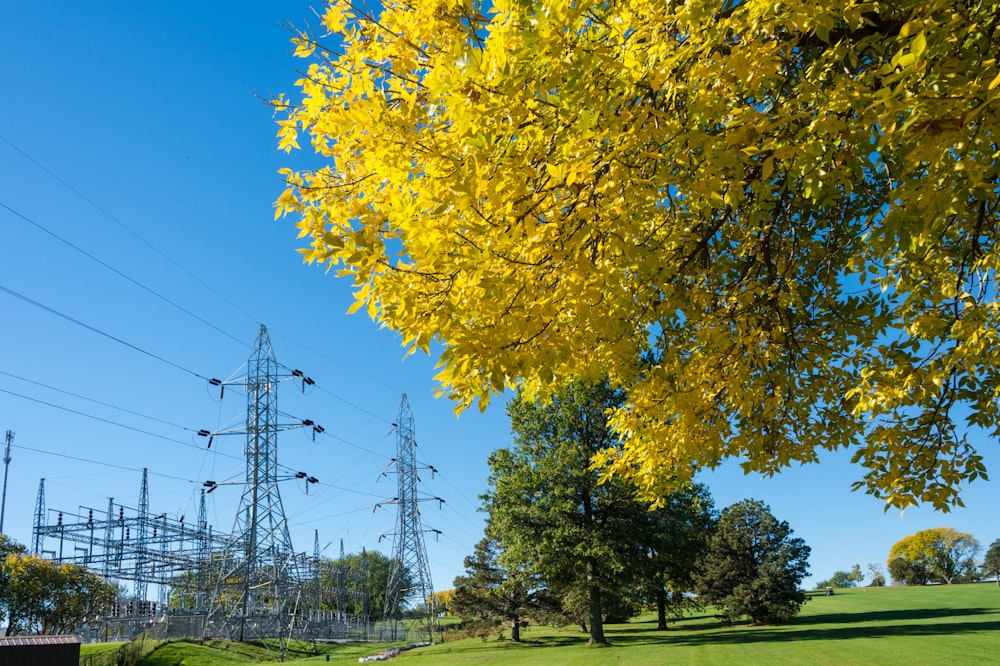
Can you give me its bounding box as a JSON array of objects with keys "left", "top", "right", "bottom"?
[{"left": 381, "top": 393, "right": 444, "bottom": 641}]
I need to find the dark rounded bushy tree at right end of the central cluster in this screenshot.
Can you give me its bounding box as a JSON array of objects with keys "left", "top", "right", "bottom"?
[{"left": 697, "top": 499, "right": 809, "bottom": 624}]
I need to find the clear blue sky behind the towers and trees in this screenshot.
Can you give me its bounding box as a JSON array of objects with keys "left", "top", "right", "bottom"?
[{"left": 0, "top": 0, "right": 1000, "bottom": 589}]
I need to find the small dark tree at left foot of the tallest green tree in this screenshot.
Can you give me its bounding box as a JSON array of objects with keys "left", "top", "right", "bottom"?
[{"left": 451, "top": 536, "right": 551, "bottom": 643}]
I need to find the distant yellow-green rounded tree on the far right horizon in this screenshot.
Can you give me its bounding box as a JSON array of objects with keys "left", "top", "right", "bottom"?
[{"left": 889, "top": 527, "right": 979, "bottom": 585}]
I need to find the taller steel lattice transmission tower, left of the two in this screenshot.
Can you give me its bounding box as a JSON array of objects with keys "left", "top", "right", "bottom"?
[{"left": 209, "top": 325, "right": 321, "bottom": 640}]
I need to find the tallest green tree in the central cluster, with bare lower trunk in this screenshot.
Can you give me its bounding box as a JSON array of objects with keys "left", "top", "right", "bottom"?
[{"left": 483, "top": 382, "right": 637, "bottom": 644}]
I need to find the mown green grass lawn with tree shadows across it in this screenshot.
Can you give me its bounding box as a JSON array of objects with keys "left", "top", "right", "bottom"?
[{"left": 90, "top": 583, "right": 1000, "bottom": 666}]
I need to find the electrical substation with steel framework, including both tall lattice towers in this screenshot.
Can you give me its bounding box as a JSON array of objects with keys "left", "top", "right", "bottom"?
[{"left": 30, "top": 325, "right": 444, "bottom": 645}]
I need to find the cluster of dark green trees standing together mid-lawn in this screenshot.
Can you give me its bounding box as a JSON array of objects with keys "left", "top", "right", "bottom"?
[{"left": 449, "top": 382, "right": 809, "bottom": 643}]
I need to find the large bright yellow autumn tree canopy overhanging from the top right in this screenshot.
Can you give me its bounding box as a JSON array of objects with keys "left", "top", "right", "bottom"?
[{"left": 274, "top": 0, "right": 1000, "bottom": 509}]
